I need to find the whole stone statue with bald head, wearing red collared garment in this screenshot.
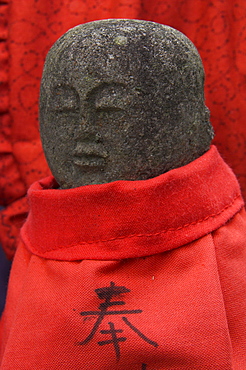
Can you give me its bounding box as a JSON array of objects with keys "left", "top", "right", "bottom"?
[{"left": 0, "top": 20, "right": 246, "bottom": 370}]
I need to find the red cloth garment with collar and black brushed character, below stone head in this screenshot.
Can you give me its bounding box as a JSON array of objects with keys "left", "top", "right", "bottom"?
[{"left": 0, "top": 147, "right": 246, "bottom": 370}]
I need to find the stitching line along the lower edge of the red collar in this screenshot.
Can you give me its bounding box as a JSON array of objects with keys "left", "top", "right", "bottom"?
[{"left": 26, "top": 194, "right": 243, "bottom": 254}]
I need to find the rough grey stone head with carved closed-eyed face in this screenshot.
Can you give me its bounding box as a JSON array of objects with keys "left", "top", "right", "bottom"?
[{"left": 40, "top": 19, "right": 213, "bottom": 188}]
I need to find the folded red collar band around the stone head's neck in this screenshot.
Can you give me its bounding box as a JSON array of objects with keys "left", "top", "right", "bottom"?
[{"left": 21, "top": 146, "right": 243, "bottom": 261}]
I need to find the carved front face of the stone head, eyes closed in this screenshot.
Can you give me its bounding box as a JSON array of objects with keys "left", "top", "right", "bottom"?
[{"left": 42, "top": 44, "right": 153, "bottom": 187}]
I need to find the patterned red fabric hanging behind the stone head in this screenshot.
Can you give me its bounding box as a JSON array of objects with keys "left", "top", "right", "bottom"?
[{"left": 0, "top": 0, "right": 246, "bottom": 257}]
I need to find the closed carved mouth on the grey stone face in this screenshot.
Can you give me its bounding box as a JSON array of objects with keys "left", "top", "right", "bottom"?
[{"left": 73, "top": 143, "right": 108, "bottom": 169}]
